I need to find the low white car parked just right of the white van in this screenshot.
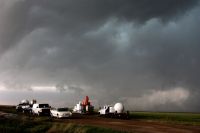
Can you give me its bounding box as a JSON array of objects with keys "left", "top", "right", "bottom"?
[{"left": 50, "top": 108, "right": 72, "bottom": 118}]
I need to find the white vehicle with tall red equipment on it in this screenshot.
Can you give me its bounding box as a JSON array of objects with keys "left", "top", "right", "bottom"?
[{"left": 73, "top": 96, "right": 94, "bottom": 114}]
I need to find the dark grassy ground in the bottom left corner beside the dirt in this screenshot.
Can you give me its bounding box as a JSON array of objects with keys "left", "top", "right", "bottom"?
[{"left": 0, "top": 116, "right": 121, "bottom": 133}]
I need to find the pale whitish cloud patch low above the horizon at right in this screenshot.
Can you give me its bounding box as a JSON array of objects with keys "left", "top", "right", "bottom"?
[{"left": 124, "top": 87, "right": 190, "bottom": 111}]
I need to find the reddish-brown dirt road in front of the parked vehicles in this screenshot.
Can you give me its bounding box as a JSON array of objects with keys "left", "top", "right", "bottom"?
[{"left": 54, "top": 116, "right": 200, "bottom": 133}]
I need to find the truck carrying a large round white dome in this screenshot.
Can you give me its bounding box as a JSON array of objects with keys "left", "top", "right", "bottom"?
[{"left": 98, "top": 103, "right": 129, "bottom": 118}]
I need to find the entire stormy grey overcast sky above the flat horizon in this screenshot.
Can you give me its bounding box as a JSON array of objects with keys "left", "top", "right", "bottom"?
[{"left": 0, "top": 0, "right": 200, "bottom": 111}]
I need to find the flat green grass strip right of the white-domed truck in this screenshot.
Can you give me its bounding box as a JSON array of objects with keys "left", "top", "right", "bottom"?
[{"left": 130, "top": 112, "right": 200, "bottom": 125}]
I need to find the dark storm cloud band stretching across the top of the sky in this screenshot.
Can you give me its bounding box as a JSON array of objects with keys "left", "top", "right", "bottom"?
[{"left": 0, "top": 0, "right": 197, "bottom": 52}]
